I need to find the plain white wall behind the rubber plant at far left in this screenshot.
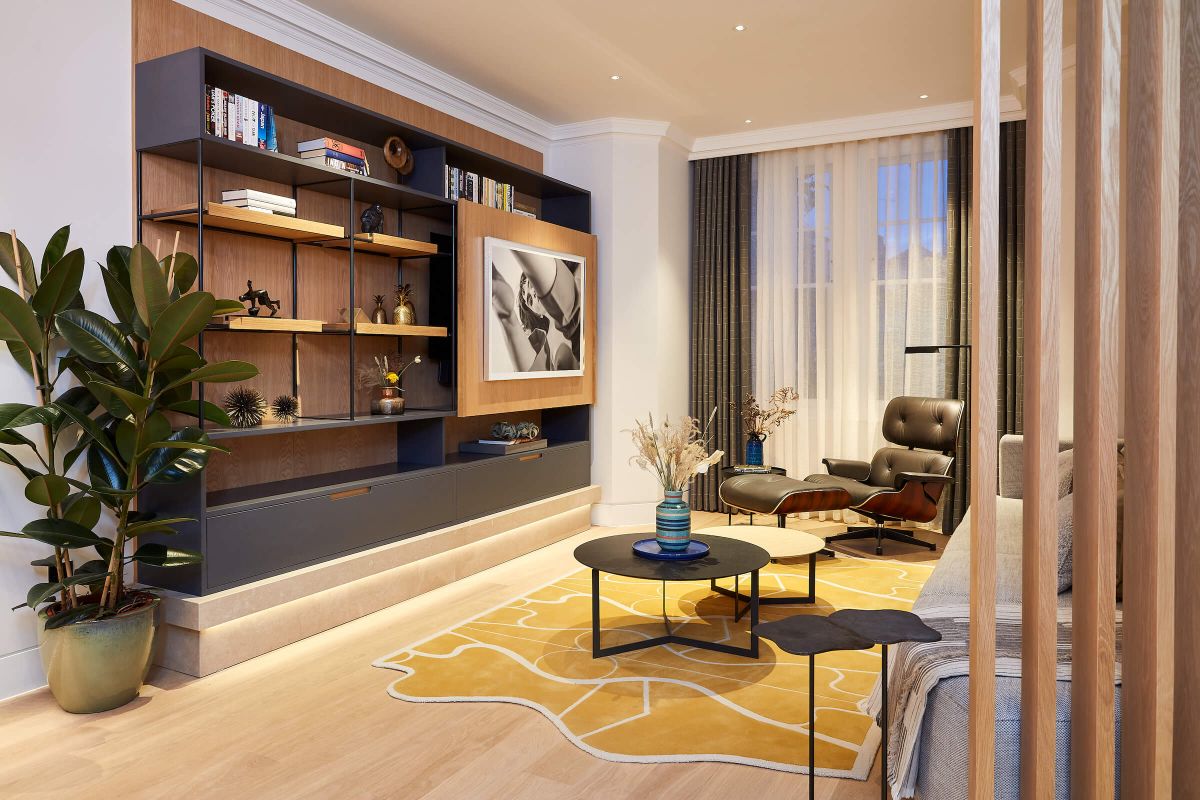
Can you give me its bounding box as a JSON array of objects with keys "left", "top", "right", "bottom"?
[{"left": 0, "top": 0, "right": 133, "bottom": 698}]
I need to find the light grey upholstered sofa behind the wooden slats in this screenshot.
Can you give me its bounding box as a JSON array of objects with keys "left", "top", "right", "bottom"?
[{"left": 902, "top": 435, "right": 1121, "bottom": 800}]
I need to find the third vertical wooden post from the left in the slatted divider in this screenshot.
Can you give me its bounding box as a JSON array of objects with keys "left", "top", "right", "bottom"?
[{"left": 1070, "top": 0, "right": 1121, "bottom": 800}]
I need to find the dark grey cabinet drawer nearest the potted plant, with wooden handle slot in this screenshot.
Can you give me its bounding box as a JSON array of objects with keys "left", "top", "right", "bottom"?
[{"left": 204, "top": 473, "right": 455, "bottom": 591}]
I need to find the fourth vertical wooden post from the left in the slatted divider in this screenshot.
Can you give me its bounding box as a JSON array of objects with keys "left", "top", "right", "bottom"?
[{"left": 1121, "top": 0, "right": 1180, "bottom": 800}]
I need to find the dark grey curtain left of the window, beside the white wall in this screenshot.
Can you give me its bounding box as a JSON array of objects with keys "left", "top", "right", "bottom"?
[{"left": 690, "top": 155, "right": 751, "bottom": 511}]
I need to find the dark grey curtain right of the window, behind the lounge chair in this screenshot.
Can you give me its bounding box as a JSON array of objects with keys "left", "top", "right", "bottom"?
[{"left": 942, "top": 120, "right": 1025, "bottom": 533}]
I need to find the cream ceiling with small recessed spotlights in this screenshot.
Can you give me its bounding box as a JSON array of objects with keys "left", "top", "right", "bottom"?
[{"left": 304, "top": 0, "right": 1074, "bottom": 137}]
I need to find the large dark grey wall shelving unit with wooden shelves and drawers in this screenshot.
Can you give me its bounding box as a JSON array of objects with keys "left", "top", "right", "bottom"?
[{"left": 134, "top": 49, "right": 590, "bottom": 595}]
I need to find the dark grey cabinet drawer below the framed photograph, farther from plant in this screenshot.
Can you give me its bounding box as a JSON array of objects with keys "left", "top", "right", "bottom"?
[{"left": 457, "top": 441, "right": 592, "bottom": 519}]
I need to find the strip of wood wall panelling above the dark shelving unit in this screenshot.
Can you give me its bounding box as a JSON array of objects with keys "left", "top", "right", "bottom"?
[{"left": 133, "top": 0, "right": 542, "bottom": 172}]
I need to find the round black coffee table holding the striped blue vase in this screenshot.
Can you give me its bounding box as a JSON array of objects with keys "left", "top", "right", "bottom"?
[{"left": 575, "top": 531, "right": 770, "bottom": 658}]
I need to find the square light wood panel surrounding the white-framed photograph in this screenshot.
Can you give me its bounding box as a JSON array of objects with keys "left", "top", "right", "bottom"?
[{"left": 457, "top": 200, "right": 596, "bottom": 416}]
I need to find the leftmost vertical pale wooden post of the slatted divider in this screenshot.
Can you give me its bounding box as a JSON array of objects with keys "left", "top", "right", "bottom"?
[{"left": 967, "top": 0, "right": 1000, "bottom": 800}]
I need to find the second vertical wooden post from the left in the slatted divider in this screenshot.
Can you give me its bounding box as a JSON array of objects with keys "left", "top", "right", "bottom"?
[{"left": 1021, "top": 0, "right": 1062, "bottom": 800}]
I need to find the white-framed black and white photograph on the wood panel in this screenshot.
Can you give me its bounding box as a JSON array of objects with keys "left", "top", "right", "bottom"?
[{"left": 484, "top": 236, "right": 590, "bottom": 380}]
